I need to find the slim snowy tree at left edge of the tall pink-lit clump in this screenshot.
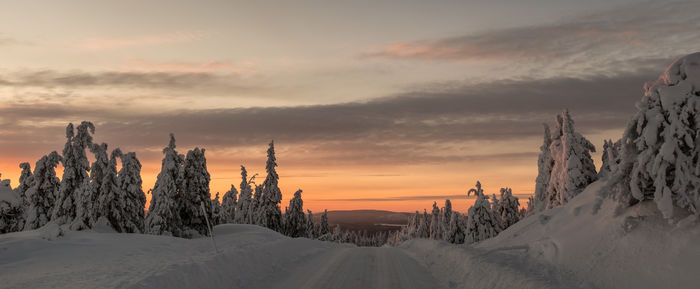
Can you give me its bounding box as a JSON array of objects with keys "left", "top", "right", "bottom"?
[{"left": 533, "top": 124, "right": 554, "bottom": 212}]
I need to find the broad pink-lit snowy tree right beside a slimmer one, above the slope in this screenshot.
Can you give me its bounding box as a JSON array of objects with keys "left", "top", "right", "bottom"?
[{"left": 547, "top": 110, "right": 598, "bottom": 208}]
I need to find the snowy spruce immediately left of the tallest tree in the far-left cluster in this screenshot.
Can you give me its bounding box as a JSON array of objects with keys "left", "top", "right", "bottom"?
[{"left": 20, "top": 151, "right": 61, "bottom": 230}]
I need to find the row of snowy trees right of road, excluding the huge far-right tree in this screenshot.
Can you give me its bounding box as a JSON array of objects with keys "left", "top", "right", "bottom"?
[{"left": 389, "top": 110, "right": 600, "bottom": 244}]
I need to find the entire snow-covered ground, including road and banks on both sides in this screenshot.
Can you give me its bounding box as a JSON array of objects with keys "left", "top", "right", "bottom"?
[{"left": 0, "top": 182, "right": 700, "bottom": 289}]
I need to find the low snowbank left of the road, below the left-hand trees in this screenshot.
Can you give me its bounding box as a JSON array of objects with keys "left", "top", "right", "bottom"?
[{"left": 0, "top": 225, "right": 344, "bottom": 288}]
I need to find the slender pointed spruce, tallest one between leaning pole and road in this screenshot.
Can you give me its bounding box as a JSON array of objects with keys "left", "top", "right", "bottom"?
[{"left": 256, "top": 141, "right": 284, "bottom": 232}]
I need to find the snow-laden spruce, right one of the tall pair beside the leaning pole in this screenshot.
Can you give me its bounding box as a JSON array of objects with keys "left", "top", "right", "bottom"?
[{"left": 178, "top": 147, "right": 212, "bottom": 237}]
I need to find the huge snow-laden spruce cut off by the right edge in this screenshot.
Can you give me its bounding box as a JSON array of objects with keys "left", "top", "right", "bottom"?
[{"left": 601, "top": 53, "right": 700, "bottom": 225}]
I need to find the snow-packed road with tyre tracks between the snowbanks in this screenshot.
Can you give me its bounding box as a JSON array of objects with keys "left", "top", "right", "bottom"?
[{"left": 272, "top": 247, "right": 437, "bottom": 289}]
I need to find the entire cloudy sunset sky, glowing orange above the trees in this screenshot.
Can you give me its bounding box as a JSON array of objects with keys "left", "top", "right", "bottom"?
[{"left": 0, "top": 0, "right": 700, "bottom": 211}]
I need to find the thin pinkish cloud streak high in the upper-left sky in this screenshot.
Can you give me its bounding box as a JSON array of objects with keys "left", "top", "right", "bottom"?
[{"left": 77, "top": 30, "right": 212, "bottom": 51}]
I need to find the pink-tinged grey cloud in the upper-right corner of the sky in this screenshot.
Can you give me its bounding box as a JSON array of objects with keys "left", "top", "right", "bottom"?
[{"left": 360, "top": 1, "right": 700, "bottom": 74}]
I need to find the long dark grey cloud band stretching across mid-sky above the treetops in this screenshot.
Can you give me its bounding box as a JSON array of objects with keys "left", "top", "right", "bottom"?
[{"left": 0, "top": 64, "right": 660, "bottom": 165}]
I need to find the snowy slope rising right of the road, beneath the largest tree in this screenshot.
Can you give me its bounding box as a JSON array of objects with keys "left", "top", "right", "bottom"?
[{"left": 402, "top": 180, "right": 700, "bottom": 289}]
